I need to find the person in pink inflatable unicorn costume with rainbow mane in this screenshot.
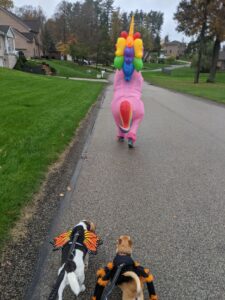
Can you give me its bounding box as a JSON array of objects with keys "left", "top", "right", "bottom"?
[{"left": 111, "top": 17, "right": 144, "bottom": 148}]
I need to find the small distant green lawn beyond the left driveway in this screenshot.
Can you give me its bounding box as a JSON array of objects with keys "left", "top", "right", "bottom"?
[{"left": 33, "top": 59, "right": 99, "bottom": 78}]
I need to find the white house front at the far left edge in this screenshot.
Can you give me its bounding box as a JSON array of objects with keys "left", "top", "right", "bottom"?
[{"left": 0, "top": 25, "right": 17, "bottom": 69}]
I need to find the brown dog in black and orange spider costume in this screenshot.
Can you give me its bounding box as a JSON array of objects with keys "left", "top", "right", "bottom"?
[{"left": 91, "top": 235, "right": 158, "bottom": 300}]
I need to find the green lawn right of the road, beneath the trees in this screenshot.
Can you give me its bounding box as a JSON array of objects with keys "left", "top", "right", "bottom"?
[{"left": 143, "top": 68, "right": 225, "bottom": 103}]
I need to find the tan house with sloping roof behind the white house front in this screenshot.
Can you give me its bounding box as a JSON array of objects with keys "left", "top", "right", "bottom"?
[{"left": 0, "top": 6, "right": 43, "bottom": 58}]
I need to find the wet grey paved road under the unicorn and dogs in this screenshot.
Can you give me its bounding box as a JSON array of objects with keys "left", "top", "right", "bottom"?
[{"left": 29, "top": 76, "right": 225, "bottom": 300}]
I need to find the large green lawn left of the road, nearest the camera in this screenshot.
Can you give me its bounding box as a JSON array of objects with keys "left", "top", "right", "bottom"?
[{"left": 0, "top": 68, "right": 104, "bottom": 248}]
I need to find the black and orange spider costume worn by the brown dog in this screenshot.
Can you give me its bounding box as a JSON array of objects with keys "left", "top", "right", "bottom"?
[{"left": 92, "top": 254, "right": 158, "bottom": 300}]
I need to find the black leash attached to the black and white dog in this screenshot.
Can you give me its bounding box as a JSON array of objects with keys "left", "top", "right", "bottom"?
[{"left": 48, "top": 232, "right": 79, "bottom": 300}]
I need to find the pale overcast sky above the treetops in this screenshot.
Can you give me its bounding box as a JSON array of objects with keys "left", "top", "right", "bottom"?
[{"left": 14, "top": 0, "right": 189, "bottom": 41}]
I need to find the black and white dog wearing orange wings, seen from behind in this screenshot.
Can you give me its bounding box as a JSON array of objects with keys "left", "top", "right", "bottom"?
[{"left": 48, "top": 220, "right": 100, "bottom": 300}]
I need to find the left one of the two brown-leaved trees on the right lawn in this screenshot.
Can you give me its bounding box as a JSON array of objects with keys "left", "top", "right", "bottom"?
[{"left": 174, "top": 0, "right": 212, "bottom": 83}]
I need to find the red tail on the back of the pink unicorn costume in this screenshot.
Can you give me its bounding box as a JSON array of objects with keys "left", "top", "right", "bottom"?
[{"left": 119, "top": 100, "right": 133, "bottom": 133}]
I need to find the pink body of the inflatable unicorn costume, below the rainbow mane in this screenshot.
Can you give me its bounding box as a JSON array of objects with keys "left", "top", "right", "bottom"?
[{"left": 111, "top": 70, "right": 144, "bottom": 142}]
